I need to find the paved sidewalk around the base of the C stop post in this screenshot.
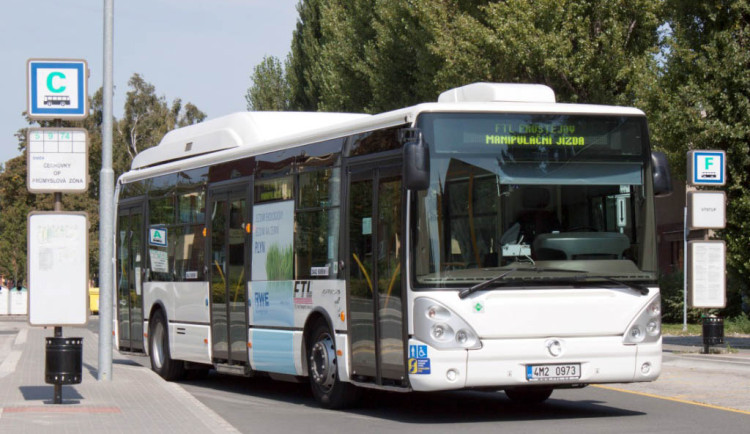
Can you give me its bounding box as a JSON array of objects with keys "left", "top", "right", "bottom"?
[{"left": 0, "top": 317, "right": 238, "bottom": 434}]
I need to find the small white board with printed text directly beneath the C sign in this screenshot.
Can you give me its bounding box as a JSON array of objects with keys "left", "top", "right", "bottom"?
[{"left": 26, "top": 128, "right": 89, "bottom": 193}]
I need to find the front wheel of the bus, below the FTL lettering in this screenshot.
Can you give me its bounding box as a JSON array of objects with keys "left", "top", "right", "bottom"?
[{"left": 307, "top": 321, "right": 359, "bottom": 409}]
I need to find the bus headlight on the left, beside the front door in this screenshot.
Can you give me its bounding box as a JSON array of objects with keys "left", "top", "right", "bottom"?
[{"left": 414, "top": 297, "right": 482, "bottom": 350}]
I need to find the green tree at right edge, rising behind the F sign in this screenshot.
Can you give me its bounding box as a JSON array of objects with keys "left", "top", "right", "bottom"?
[{"left": 644, "top": 0, "right": 750, "bottom": 302}]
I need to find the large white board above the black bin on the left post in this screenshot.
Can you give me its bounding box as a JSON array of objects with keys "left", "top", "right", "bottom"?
[{"left": 28, "top": 211, "right": 89, "bottom": 327}]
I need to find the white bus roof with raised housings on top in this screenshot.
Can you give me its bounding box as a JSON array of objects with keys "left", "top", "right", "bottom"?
[{"left": 125, "top": 83, "right": 644, "bottom": 179}]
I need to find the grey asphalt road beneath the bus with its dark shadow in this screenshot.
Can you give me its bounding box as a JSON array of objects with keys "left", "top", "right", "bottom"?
[{"left": 89, "top": 312, "right": 750, "bottom": 434}]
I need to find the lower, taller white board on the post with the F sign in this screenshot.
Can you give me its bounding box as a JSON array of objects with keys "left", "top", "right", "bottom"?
[{"left": 687, "top": 240, "right": 727, "bottom": 309}]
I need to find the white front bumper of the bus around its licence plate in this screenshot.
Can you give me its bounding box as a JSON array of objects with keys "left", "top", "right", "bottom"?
[{"left": 408, "top": 336, "right": 662, "bottom": 391}]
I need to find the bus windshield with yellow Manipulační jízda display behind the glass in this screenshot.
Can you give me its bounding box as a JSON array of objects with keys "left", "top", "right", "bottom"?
[{"left": 411, "top": 113, "right": 657, "bottom": 288}]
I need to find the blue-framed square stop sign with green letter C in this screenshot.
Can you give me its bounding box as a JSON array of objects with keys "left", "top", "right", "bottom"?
[{"left": 26, "top": 59, "right": 89, "bottom": 119}]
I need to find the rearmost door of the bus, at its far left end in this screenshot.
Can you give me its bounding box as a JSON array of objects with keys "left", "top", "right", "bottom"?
[{"left": 117, "top": 203, "right": 143, "bottom": 351}]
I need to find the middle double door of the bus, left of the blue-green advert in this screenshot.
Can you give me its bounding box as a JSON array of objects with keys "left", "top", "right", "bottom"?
[{"left": 206, "top": 187, "right": 249, "bottom": 364}]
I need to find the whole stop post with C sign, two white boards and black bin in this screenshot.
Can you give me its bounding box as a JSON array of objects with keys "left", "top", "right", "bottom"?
[{"left": 26, "top": 59, "right": 89, "bottom": 404}]
